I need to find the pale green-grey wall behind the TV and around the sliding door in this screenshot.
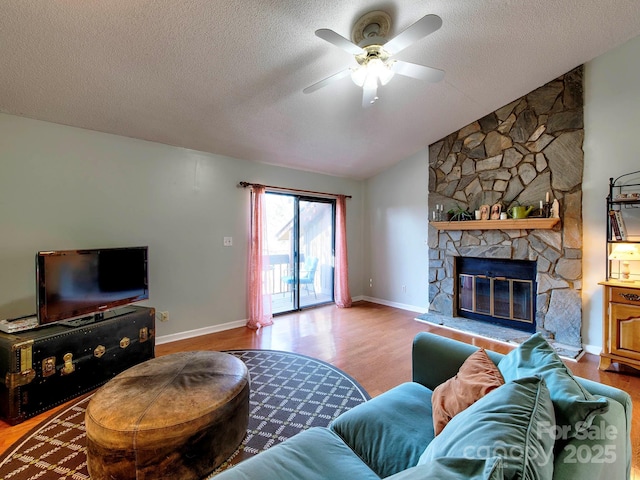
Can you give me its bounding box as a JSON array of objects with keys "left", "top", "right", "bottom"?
[{"left": 0, "top": 114, "right": 364, "bottom": 336}]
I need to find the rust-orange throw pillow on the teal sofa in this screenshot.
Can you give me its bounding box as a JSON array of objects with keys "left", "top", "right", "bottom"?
[{"left": 431, "top": 348, "right": 504, "bottom": 435}]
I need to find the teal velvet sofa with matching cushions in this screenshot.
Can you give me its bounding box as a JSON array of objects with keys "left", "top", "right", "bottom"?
[{"left": 215, "top": 332, "right": 632, "bottom": 480}]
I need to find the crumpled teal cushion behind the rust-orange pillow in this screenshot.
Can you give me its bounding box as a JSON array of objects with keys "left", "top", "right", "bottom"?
[{"left": 498, "top": 333, "right": 609, "bottom": 438}]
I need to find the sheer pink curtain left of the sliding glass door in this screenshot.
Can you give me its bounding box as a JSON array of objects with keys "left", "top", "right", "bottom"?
[{"left": 247, "top": 185, "right": 273, "bottom": 330}]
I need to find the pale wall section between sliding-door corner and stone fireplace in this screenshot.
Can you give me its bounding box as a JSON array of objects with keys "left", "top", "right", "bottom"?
[{"left": 364, "top": 150, "right": 429, "bottom": 312}]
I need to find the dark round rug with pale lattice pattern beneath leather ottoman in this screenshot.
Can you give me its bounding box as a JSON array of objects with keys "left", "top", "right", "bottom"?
[{"left": 0, "top": 350, "right": 370, "bottom": 480}]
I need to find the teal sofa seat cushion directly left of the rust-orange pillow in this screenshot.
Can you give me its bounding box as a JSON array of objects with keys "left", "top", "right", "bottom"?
[{"left": 331, "top": 382, "right": 433, "bottom": 478}]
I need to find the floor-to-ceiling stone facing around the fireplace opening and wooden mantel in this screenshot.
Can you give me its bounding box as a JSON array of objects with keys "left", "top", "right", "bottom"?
[{"left": 429, "top": 66, "right": 584, "bottom": 348}]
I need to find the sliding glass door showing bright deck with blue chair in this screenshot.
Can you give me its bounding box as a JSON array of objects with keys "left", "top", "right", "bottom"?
[{"left": 264, "top": 193, "right": 335, "bottom": 314}]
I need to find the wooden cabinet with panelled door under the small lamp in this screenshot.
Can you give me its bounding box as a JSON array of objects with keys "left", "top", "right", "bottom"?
[{"left": 600, "top": 281, "right": 640, "bottom": 370}]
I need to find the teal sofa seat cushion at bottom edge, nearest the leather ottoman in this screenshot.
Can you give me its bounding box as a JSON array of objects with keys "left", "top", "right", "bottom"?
[{"left": 210, "top": 427, "right": 379, "bottom": 480}]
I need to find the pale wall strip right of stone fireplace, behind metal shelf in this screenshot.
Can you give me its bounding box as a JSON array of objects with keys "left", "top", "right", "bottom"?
[{"left": 582, "top": 32, "right": 640, "bottom": 353}]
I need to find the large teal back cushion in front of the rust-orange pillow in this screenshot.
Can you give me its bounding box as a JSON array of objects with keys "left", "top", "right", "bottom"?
[{"left": 418, "top": 377, "right": 555, "bottom": 479}]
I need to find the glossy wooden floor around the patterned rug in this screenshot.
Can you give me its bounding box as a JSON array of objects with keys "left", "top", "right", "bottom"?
[{"left": 0, "top": 302, "right": 640, "bottom": 480}]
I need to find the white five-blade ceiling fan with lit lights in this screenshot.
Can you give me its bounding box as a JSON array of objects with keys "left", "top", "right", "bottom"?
[{"left": 303, "top": 10, "right": 444, "bottom": 107}]
